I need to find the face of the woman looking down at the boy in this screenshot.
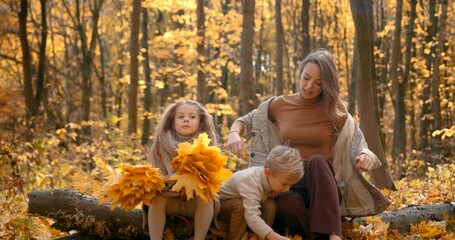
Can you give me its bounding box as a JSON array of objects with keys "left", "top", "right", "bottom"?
[{"left": 299, "top": 62, "right": 322, "bottom": 100}]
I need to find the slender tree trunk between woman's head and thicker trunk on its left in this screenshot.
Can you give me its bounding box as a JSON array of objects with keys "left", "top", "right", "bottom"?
[{"left": 275, "top": 0, "right": 284, "bottom": 96}]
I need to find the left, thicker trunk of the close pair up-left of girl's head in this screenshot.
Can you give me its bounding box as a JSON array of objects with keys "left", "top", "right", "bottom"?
[{"left": 128, "top": 0, "right": 141, "bottom": 134}]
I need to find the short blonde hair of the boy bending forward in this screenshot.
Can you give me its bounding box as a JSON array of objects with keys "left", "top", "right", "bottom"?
[{"left": 264, "top": 145, "right": 304, "bottom": 182}]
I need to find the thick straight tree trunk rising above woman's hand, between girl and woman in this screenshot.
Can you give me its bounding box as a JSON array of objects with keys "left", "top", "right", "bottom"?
[{"left": 239, "top": 0, "right": 255, "bottom": 116}]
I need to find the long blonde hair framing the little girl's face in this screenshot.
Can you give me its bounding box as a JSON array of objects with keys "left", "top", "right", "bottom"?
[{"left": 148, "top": 100, "right": 218, "bottom": 174}]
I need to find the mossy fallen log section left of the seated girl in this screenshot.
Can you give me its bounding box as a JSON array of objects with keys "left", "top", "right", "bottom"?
[{"left": 28, "top": 189, "right": 149, "bottom": 239}]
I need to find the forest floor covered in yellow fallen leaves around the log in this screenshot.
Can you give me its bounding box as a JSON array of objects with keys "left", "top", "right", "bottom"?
[{"left": 0, "top": 131, "right": 455, "bottom": 240}]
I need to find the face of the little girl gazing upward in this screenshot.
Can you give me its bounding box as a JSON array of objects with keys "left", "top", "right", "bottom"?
[{"left": 173, "top": 104, "right": 201, "bottom": 137}]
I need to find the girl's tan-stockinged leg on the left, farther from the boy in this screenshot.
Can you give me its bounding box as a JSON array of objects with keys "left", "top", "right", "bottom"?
[{"left": 148, "top": 196, "right": 167, "bottom": 240}]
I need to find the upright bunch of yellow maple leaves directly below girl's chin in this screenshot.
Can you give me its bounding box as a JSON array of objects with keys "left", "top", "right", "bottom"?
[{"left": 171, "top": 133, "right": 232, "bottom": 201}]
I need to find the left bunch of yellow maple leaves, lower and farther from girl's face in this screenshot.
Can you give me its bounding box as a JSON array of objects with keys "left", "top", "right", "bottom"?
[{"left": 100, "top": 164, "right": 164, "bottom": 210}]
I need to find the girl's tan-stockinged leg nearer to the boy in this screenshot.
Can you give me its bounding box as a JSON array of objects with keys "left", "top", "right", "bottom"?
[{"left": 194, "top": 197, "right": 213, "bottom": 240}]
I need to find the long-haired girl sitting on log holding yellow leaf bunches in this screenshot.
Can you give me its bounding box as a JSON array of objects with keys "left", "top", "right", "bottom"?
[{"left": 143, "top": 100, "right": 217, "bottom": 240}]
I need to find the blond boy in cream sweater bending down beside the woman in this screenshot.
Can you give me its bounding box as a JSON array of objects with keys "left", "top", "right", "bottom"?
[{"left": 215, "top": 145, "right": 304, "bottom": 239}]
